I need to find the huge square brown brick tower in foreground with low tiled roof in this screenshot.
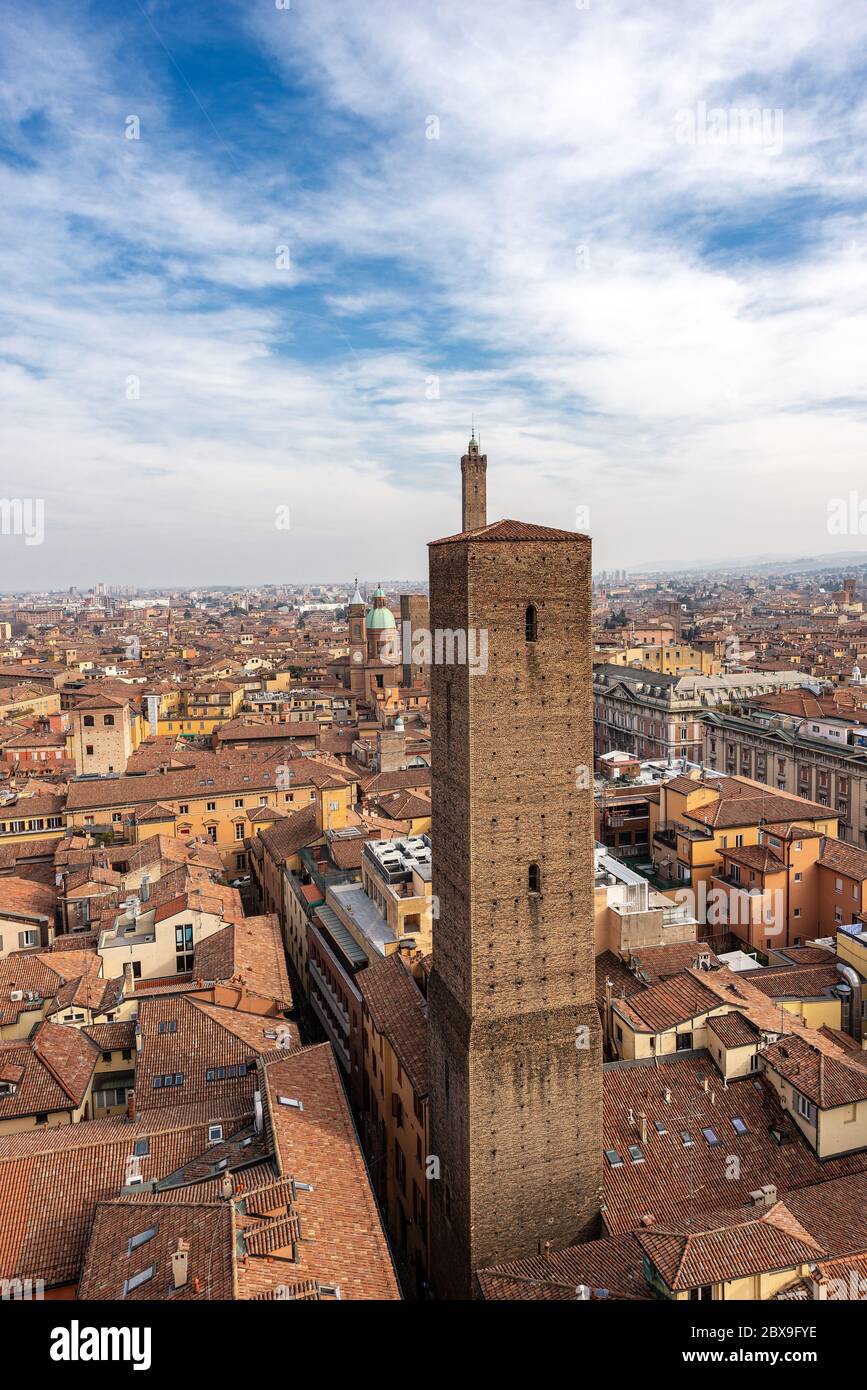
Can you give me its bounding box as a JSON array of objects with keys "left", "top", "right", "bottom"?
[{"left": 429, "top": 460, "right": 602, "bottom": 1298}]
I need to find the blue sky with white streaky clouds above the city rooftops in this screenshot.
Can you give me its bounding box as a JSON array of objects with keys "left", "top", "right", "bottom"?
[{"left": 0, "top": 0, "right": 867, "bottom": 589}]
